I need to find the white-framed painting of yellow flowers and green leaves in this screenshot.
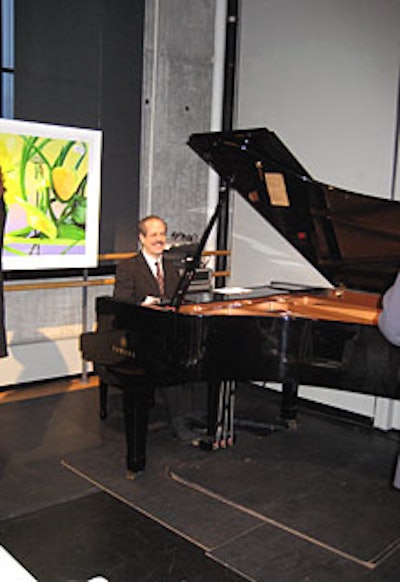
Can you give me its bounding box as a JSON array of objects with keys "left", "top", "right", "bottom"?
[{"left": 0, "top": 119, "right": 102, "bottom": 271}]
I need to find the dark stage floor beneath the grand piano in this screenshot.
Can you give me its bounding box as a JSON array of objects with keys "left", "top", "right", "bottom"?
[{"left": 0, "top": 378, "right": 400, "bottom": 582}]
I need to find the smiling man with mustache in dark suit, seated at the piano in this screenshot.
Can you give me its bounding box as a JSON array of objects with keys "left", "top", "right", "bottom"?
[{"left": 114, "top": 215, "right": 205, "bottom": 444}]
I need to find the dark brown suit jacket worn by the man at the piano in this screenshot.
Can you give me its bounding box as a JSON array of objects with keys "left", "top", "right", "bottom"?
[{"left": 114, "top": 253, "right": 180, "bottom": 303}]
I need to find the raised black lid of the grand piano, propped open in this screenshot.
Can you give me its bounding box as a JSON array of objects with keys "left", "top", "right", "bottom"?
[{"left": 188, "top": 128, "right": 400, "bottom": 293}]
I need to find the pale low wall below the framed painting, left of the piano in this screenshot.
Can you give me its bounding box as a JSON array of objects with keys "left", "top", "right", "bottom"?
[{"left": 0, "top": 278, "right": 113, "bottom": 387}]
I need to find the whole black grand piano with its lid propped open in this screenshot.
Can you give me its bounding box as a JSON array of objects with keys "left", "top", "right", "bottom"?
[{"left": 82, "top": 128, "right": 400, "bottom": 480}]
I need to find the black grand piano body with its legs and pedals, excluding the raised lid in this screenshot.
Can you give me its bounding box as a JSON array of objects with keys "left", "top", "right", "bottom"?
[{"left": 87, "top": 290, "right": 400, "bottom": 475}]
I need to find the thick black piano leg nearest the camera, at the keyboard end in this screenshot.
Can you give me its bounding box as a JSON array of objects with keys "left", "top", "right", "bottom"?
[{"left": 123, "top": 376, "right": 152, "bottom": 479}]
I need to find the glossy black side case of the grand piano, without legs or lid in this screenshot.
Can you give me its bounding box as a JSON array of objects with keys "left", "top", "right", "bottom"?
[{"left": 97, "top": 292, "right": 400, "bottom": 398}]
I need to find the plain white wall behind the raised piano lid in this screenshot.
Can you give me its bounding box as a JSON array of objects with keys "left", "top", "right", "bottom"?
[{"left": 231, "top": 0, "right": 400, "bottom": 428}]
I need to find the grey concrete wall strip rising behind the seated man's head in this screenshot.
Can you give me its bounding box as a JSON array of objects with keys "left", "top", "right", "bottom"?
[{"left": 140, "top": 0, "right": 216, "bottom": 240}]
